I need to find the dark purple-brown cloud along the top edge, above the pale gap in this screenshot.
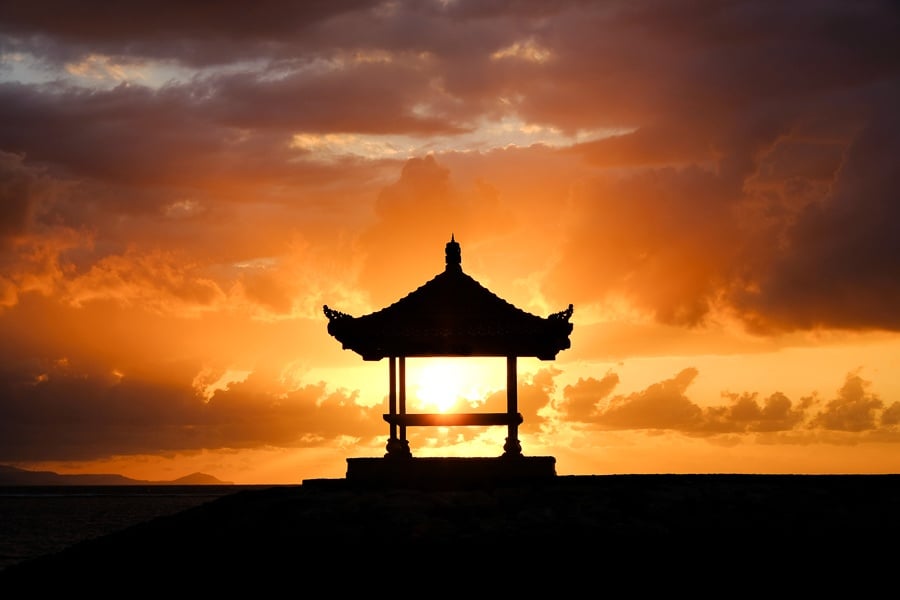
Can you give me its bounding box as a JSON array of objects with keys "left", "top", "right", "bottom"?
[{"left": 0, "top": 0, "right": 590, "bottom": 66}]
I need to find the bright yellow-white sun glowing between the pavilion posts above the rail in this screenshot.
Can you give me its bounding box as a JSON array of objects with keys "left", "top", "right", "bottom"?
[{"left": 407, "top": 358, "right": 504, "bottom": 413}]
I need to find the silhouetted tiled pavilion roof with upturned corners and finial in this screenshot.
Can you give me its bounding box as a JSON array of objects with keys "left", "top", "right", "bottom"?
[{"left": 323, "top": 236, "right": 572, "bottom": 360}]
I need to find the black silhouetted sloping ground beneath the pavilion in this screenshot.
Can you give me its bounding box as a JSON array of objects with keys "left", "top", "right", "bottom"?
[{"left": 0, "top": 475, "right": 900, "bottom": 598}]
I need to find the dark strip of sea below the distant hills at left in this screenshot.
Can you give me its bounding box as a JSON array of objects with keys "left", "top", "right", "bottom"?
[{"left": 0, "top": 485, "right": 273, "bottom": 571}]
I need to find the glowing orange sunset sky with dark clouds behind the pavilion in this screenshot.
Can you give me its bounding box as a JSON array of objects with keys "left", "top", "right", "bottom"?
[{"left": 0, "top": 0, "right": 900, "bottom": 484}]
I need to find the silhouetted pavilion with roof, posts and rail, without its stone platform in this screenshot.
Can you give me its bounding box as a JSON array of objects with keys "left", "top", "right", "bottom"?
[{"left": 323, "top": 235, "right": 573, "bottom": 468}]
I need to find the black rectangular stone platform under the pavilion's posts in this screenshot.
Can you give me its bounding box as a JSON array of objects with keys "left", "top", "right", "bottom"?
[{"left": 346, "top": 456, "right": 556, "bottom": 489}]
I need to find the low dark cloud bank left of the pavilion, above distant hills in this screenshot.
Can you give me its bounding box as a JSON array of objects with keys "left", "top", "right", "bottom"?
[{"left": 0, "top": 359, "right": 384, "bottom": 462}]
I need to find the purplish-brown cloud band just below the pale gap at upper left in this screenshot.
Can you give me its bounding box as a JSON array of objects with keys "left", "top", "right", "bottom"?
[{"left": 0, "top": 65, "right": 462, "bottom": 189}]
